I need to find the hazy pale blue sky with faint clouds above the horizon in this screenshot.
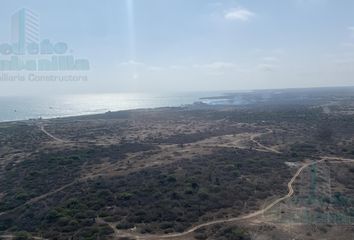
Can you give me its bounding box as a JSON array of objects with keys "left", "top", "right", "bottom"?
[{"left": 0, "top": 0, "right": 354, "bottom": 95}]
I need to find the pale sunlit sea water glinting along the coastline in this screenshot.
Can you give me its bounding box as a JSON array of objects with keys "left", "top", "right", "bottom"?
[{"left": 0, "top": 92, "right": 224, "bottom": 122}]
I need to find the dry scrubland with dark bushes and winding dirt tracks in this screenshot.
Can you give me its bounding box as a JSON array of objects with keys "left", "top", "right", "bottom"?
[{"left": 0, "top": 90, "right": 354, "bottom": 240}]
